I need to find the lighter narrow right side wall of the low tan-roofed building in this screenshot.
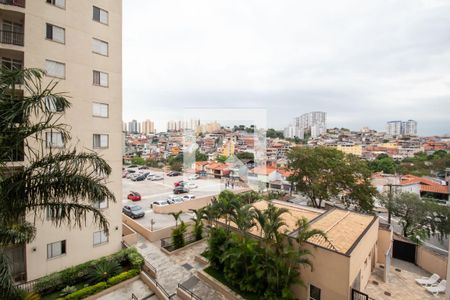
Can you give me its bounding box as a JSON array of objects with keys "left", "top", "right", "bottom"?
[{"left": 348, "top": 219, "right": 379, "bottom": 293}]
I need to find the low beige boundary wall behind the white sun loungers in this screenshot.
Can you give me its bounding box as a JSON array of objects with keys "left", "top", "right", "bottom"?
[{"left": 416, "top": 246, "right": 448, "bottom": 278}]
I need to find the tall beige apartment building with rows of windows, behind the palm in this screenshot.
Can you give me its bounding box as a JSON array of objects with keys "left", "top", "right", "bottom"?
[{"left": 0, "top": 0, "right": 122, "bottom": 280}]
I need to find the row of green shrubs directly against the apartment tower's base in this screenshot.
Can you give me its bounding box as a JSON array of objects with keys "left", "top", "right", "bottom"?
[{"left": 34, "top": 248, "right": 144, "bottom": 295}]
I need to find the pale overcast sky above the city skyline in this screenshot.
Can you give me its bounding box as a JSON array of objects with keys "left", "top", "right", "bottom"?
[{"left": 123, "top": 0, "right": 450, "bottom": 135}]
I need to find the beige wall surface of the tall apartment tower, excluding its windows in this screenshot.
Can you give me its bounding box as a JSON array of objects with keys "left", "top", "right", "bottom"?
[{"left": 0, "top": 0, "right": 122, "bottom": 280}]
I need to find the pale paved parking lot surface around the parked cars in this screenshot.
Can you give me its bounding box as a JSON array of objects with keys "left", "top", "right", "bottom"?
[{"left": 122, "top": 171, "right": 244, "bottom": 230}]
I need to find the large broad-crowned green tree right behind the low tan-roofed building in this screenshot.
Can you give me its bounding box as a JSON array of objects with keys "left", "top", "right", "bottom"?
[{"left": 288, "top": 147, "right": 376, "bottom": 212}]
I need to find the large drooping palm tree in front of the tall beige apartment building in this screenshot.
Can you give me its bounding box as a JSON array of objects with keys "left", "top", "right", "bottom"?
[{"left": 0, "top": 69, "right": 115, "bottom": 299}]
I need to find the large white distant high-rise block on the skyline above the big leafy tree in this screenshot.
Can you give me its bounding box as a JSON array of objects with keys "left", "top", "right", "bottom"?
[{"left": 285, "top": 111, "right": 327, "bottom": 138}]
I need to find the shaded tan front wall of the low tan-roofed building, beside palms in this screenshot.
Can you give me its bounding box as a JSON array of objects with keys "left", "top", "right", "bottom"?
[{"left": 292, "top": 244, "right": 350, "bottom": 300}]
